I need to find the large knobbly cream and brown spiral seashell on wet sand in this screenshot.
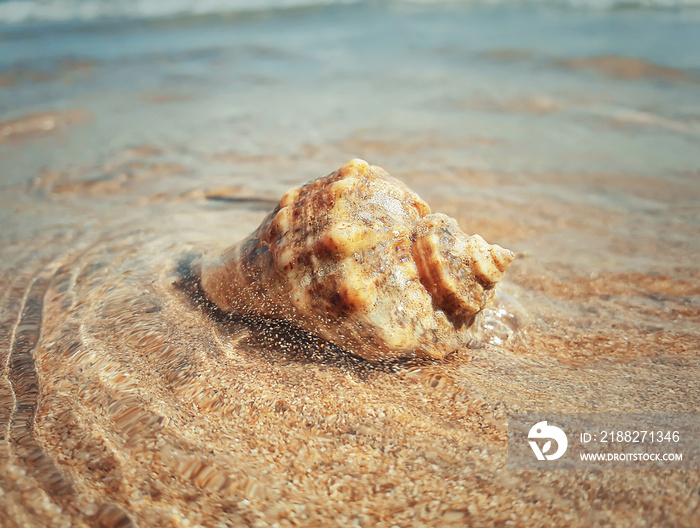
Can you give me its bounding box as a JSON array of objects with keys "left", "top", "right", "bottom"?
[{"left": 200, "top": 159, "right": 514, "bottom": 361}]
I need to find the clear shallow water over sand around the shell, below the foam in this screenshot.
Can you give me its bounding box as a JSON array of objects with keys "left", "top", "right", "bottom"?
[{"left": 0, "top": 2, "right": 700, "bottom": 526}]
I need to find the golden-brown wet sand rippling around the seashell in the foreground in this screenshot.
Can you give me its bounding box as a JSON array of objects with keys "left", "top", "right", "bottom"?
[{"left": 0, "top": 138, "right": 700, "bottom": 527}]
